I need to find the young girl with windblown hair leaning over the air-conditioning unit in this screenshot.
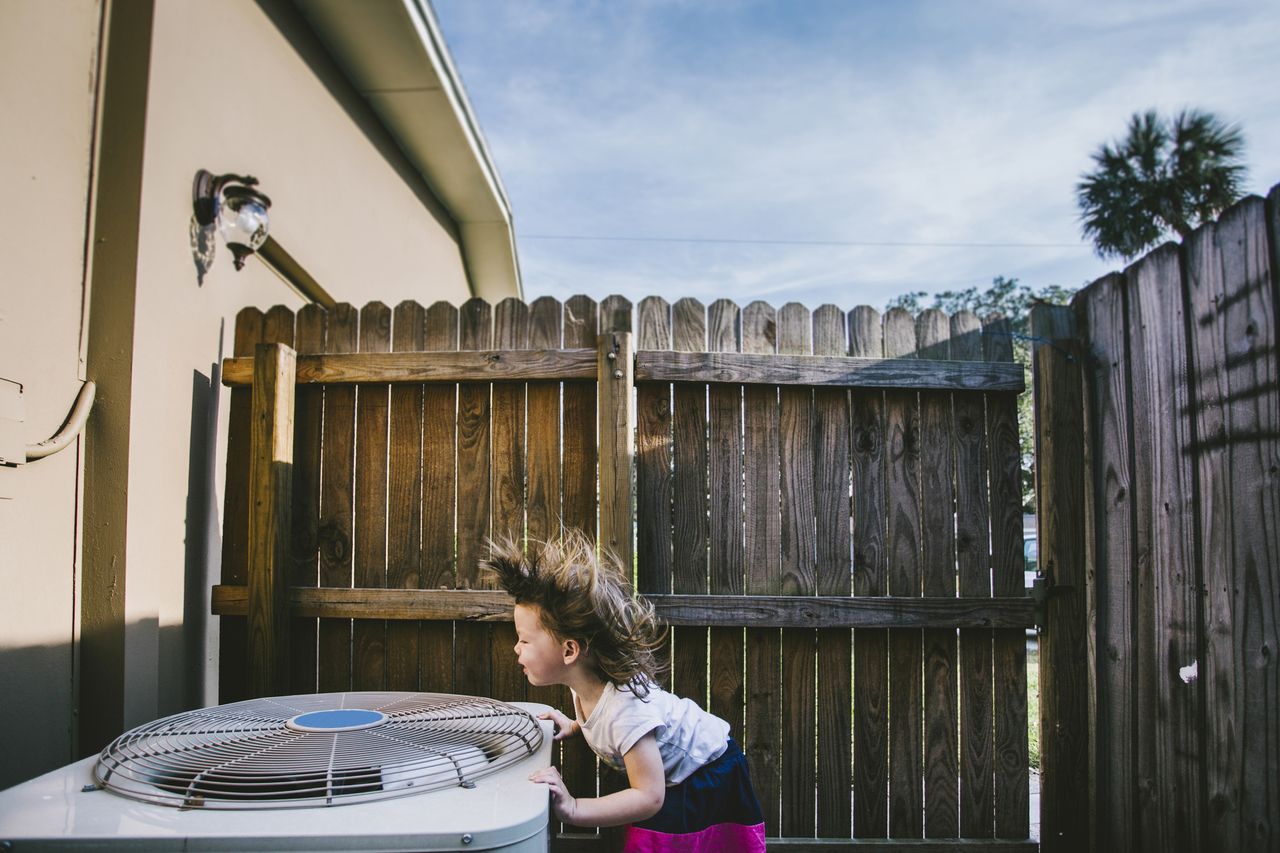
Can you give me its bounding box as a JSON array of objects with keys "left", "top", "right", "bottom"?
[{"left": 489, "top": 533, "right": 764, "bottom": 853}]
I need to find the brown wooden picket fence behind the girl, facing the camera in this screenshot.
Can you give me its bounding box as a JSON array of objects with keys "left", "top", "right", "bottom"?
[{"left": 214, "top": 290, "right": 1037, "bottom": 850}]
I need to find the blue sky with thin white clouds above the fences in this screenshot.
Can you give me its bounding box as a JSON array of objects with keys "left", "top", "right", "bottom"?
[{"left": 433, "top": 0, "right": 1280, "bottom": 310}]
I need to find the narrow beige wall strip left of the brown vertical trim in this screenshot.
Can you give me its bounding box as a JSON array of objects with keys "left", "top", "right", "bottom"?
[{"left": 0, "top": 0, "right": 99, "bottom": 786}]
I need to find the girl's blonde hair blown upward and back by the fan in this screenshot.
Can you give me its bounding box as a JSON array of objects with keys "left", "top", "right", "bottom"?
[{"left": 486, "top": 530, "right": 666, "bottom": 698}]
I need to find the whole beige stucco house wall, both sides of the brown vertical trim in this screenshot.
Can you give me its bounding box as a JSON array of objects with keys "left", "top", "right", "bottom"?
[{"left": 0, "top": 0, "right": 496, "bottom": 786}]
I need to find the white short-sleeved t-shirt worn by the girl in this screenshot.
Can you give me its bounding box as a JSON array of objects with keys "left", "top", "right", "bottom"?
[{"left": 571, "top": 684, "right": 728, "bottom": 785}]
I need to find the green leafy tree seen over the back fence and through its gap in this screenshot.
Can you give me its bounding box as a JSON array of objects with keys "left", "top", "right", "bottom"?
[{"left": 884, "top": 275, "right": 1075, "bottom": 512}]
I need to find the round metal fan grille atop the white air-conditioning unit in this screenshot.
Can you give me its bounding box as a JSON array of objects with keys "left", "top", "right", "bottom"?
[{"left": 93, "top": 693, "right": 543, "bottom": 808}]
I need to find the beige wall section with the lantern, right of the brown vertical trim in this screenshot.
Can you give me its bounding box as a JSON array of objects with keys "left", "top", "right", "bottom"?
[{"left": 125, "top": 0, "right": 470, "bottom": 725}]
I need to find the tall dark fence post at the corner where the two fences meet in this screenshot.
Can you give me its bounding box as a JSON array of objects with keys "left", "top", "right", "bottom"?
[{"left": 1029, "top": 306, "right": 1093, "bottom": 853}]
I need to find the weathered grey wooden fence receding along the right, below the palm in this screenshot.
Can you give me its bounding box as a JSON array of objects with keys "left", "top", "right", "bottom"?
[{"left": 1033, "top": 187, "right": 1280, "bottom": 853}]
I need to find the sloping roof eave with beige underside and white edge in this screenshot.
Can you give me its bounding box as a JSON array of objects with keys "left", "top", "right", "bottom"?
[{"left": 294, "top": 0, "right": 522, "bottom": 302}]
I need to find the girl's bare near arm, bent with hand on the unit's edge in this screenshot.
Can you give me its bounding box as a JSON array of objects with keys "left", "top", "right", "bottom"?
[{"left": 530, "top": 731, "right": 667, "bottom": 826}]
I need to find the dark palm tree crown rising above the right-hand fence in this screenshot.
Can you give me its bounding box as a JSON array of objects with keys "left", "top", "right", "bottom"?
[{"left": 1075, "top": 110, "right": 1244, "bottom": 257}]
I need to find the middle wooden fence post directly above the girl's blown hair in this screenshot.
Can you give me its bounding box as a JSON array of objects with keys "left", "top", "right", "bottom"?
[{"left": 596, "top": 332, "right": 636, "bottom": 563}]
